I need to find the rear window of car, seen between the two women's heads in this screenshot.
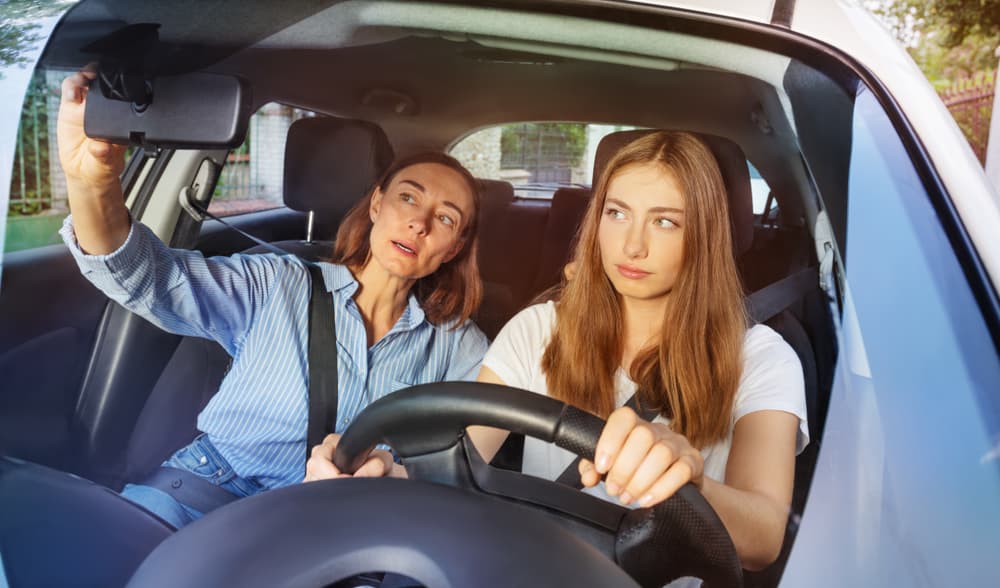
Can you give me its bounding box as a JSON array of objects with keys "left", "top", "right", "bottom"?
[{"left": 450, "top": 123, "right": 635, "bottom": 199}]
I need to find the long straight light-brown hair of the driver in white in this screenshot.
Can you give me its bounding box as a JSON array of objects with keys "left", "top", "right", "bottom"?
[{"left": 542, "top": 131, "right": 747, "bottom": 448}]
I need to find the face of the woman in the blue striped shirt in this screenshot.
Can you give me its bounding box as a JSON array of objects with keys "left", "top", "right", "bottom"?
[{"left": 369, "top": 163, "right": 475, "bottom": 280}]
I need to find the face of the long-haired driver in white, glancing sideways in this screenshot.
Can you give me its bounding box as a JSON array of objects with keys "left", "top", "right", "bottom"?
[{"left": 597, "top": 163, "right": 685, "bottom": 302}]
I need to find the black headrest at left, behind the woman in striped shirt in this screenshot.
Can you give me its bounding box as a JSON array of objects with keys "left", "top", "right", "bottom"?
[{"left": 284, "top": 117, "right": 393, "bottom": 220}]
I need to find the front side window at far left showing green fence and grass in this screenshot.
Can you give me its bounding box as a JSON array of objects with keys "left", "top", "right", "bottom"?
[{"left": 3, "top": 71, "right": 69, "bottom": 253}]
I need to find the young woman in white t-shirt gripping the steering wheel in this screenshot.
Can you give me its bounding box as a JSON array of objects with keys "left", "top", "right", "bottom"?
[{"left": 470, "top": 131, "right": 808, "bottom": 569}]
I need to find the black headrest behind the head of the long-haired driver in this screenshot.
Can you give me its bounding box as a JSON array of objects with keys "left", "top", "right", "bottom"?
[{"left": 594, "top": 129, "right": 753, "bottom": 257}]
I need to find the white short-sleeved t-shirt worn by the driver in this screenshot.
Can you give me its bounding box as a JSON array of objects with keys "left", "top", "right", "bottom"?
[{"left": 483, "top": 302, "right": 809, "bottom": 494}]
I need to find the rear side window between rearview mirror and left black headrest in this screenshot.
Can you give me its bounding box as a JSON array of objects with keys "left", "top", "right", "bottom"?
[{"left": 208, "top": 103, "right": 315, "bottom": 216}]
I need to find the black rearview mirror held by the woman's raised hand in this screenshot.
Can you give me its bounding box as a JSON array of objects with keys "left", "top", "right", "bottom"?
[{"left": 83, "top": 73, "right": 251, "bottom": 149}]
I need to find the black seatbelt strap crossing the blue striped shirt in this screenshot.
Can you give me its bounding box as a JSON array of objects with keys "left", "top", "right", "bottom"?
[{"left": 306, "top": 263, "right": 337, "bottom": 460}]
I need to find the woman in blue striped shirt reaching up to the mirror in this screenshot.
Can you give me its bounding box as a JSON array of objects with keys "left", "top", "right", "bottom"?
[{"left": 58, "top": 71, "right": 487, "bottom": 527}]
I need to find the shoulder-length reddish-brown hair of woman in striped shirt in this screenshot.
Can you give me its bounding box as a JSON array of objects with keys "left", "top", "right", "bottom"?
[{"left": 330, "top": 151, "right": 483, "bottom": 327}]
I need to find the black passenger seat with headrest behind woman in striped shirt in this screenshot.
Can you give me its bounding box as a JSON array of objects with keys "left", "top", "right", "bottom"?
[{"left": 124, "top": 117, "right": 392, "bottom": 481}]
